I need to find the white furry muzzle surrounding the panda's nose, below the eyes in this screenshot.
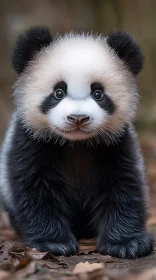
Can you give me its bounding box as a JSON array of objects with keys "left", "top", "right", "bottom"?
[{"left": 48, "top": 97, "right": 107, "bottom": 140}]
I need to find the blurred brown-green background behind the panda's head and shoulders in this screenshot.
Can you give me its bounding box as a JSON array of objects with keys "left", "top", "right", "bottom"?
[{"left": 0, "top": 0, "right": 156, "bottom": 209}]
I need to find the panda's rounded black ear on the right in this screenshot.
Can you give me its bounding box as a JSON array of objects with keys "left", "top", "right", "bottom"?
[{"left": 107, "top": 31, "right": 144, "bottom": 75}]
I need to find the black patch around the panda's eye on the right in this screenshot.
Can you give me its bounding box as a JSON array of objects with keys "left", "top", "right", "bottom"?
[{"left": 91, "top": 82, "right": 116, "bottom": 114}]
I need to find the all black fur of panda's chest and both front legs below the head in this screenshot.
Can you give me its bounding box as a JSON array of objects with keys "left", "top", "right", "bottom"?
[{"left": 4, "top": 122, "right": 152, "bottom": 258}]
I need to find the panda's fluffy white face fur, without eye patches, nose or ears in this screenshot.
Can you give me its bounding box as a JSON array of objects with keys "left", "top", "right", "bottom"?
[{"left": 14, "top": 34, "right": 137, "bottom": 140}]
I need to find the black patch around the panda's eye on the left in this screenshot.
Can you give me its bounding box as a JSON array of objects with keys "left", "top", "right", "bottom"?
[{"left": 40, "top": 81, "right": 67, "bottom": 114}]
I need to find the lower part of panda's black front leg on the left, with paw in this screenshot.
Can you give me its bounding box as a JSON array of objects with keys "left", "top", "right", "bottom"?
[{"left": 11, "top": 182, "right": 78, "bottom": 255}]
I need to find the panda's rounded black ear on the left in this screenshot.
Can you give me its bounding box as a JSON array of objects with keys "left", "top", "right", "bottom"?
[{"left": 11, "top": 26, "right": 53, "bottom": 74}]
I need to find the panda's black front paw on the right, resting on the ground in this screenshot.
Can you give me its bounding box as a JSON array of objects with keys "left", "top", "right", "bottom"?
[{"left": 97, "top": 232, "right": 153, "bottom": 259}]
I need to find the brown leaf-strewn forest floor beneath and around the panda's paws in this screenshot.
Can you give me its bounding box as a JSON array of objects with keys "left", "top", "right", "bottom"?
[{"left": 0, "top": 212, "right": 156, "bottom": 280}]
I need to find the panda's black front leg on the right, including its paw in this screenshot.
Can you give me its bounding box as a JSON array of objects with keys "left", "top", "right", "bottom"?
[{"left": 96, "top": 175, "right": 152, "bottom": 258}]
